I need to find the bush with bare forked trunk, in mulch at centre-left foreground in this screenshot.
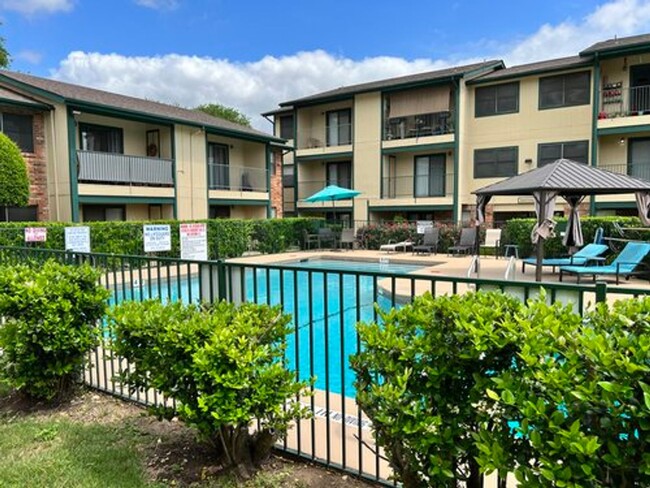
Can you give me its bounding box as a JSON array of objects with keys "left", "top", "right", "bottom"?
[{"left": 109, "top": 301, "right": 306, "bottom": 475}]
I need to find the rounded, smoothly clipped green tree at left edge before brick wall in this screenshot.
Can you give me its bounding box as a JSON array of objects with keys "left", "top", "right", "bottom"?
[{"left": 0, "top": 133, "right": 29, "bottom": 217}]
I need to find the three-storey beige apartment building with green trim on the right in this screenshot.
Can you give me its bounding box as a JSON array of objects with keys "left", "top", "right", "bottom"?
[{"left": 265, "top": 35, "right": 650, "bottom": 226}]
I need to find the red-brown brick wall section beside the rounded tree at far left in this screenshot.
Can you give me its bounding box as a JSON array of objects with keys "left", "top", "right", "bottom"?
[{"left": 23, "top": 114, "right": 50, "bottom": 220}]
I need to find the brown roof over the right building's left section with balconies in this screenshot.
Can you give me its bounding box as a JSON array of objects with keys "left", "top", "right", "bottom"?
[{"left": 280, "top": 60, "right": 503, "bottom": 107}]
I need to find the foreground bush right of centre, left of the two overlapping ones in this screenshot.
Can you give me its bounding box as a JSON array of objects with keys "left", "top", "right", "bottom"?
[{"left": 352, "top": 292, "right": 522, "bottom": 488}]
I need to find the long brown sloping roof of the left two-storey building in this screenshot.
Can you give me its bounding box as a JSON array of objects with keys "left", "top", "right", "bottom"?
[{"left": 0, "top": 70, "right": 280, "bottom": 140}]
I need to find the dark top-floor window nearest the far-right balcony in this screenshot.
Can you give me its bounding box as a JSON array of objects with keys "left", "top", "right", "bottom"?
[{"left": 539, "top": 71, "right": 591, "bottom": 110}]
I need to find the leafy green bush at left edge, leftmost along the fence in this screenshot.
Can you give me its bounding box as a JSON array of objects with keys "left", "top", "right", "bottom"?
[{"left": 0, "top": 261, "right": 108, "bottom": 400}]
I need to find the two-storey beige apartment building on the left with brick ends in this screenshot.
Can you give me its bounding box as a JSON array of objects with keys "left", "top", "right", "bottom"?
[{"left": 0, "top": 71, "right": 283, "bottom": 221}]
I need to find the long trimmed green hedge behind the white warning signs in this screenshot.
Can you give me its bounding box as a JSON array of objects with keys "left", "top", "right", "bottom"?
[{"left": 0, "top": 218, "right": 322, "bottom": 259}]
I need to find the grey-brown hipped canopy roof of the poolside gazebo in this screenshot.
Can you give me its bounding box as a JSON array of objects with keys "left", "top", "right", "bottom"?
[{"left": 474, "top": 159, "right": 650, "bottom": 196}]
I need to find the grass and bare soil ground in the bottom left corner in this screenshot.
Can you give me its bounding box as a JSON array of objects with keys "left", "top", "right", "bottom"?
[{"left": 0, "top": 384, "right": 369, "bottom": 488}]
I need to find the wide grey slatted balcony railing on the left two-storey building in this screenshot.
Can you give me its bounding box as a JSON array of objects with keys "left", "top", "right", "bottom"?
[{"left": 77, "top": 150, "right": 174, "bottom": 186}]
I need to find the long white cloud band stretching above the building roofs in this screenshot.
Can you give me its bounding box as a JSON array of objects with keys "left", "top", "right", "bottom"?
[{"left": 52, "top": 0, "right": 650, "bottom": 130}]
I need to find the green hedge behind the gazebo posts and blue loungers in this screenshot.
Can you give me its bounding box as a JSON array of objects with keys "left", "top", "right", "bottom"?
[{"left": 502, "top": 217, "right": 650, "bottom": 257}]
